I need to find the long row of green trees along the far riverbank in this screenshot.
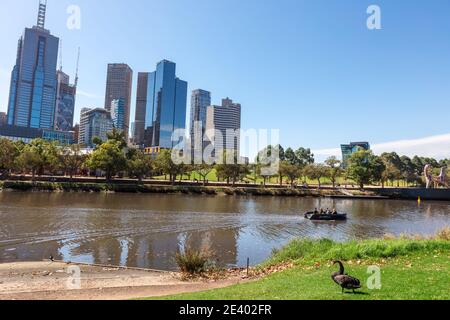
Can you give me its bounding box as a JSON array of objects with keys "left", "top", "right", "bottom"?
[{"left": 0, "top": 135, "right": 450, "bottom": 188}]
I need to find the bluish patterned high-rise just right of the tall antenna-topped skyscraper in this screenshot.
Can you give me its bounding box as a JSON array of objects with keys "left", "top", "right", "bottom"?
[{"left": 55, "top": 70, "right": 77, "bottom": 131}]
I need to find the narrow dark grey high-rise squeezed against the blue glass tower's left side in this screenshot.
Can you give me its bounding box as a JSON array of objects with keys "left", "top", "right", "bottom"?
[{"left": 132, "top": 72, "right": 149, "bottom": 146}]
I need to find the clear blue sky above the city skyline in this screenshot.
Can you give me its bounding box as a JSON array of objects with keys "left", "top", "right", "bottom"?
[{"left": 0, "top": 0, "right": 450, "bottom": 157}]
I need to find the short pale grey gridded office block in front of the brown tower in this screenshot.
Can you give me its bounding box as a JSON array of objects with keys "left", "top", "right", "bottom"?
[{"left": 78, "top": 108, "right": 114, "bottom": 148}]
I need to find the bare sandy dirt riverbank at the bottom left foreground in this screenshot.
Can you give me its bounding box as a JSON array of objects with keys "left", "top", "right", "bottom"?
[{"left": 0, "top": 261, "right": 250, "bottom": 300}]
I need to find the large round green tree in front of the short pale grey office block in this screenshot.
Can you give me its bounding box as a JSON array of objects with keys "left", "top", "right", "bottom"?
[{"left": 88, "top": 140, "right": 127, "bottom": 181}]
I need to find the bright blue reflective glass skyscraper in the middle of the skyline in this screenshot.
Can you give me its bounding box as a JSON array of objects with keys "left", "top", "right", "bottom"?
[{"left": 141, "top": 60, "right": 187, "bottom": 149}]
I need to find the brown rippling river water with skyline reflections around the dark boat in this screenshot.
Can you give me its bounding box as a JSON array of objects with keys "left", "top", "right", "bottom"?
[{"left": 0, "top": 192, "right": 450, "bottom": 270}]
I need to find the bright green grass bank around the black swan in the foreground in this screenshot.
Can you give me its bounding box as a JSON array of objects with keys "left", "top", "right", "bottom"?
[{"left": 150, "top": 229, "right": 450, "bottom": 300}]
